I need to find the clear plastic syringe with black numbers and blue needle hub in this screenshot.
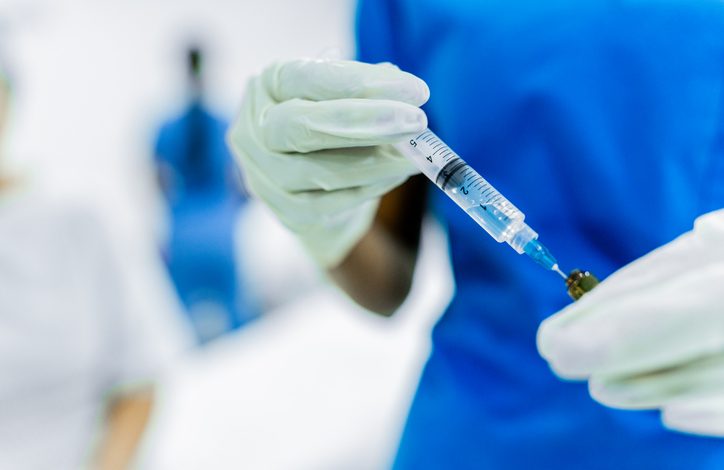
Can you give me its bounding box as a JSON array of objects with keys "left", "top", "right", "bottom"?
[{"left": 395, "top": 129, "right": 567, "bottom": 279}]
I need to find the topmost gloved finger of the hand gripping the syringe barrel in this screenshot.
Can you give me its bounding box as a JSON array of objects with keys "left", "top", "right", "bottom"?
[{"left": 262, "top": 59, "right": 430, "bottom": 106}]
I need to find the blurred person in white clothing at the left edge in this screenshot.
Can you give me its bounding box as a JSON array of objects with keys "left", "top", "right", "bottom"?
[{"left": 0, "top": 63, "right": 189, "bottom": 470}]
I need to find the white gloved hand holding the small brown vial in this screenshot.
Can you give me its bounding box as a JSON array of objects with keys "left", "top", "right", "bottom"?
[{"left": 538, "top": 210, "right": 724, "bottom": 436}]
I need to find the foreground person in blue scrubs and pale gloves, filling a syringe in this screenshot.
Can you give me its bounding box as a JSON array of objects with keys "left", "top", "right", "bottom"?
[{"left": 229, "top": 0, "right": 724, "bottom": 470}]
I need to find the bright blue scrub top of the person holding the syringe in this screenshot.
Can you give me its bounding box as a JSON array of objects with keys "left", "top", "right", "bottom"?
[{"left": 358, "top": 0, "right": 724, "bottom": 470}]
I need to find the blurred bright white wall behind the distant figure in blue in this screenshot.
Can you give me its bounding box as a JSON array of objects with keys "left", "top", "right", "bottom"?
[{"left": 0, "top": 0, "right": 354, "bottom": 242}]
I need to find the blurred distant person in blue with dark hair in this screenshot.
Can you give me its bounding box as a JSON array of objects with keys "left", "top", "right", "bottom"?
[{"left": 155, "top": 46, "right": 256, "bottom": 342}]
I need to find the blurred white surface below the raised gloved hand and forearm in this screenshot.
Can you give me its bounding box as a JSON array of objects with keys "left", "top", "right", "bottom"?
[{"left": 141, "top": 224, "right": 452, "bottom": 470}]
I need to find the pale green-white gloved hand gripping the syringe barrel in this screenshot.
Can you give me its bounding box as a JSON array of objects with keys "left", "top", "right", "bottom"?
[{"left": 227, "top": 60, "right": 429, "bottom": 267}]
